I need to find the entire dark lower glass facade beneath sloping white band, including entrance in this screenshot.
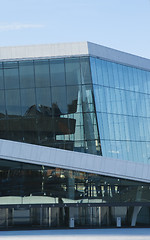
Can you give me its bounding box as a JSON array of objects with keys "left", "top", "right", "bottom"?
[{"left": 0, "top": 159, "right": 150, "bottom": 230}]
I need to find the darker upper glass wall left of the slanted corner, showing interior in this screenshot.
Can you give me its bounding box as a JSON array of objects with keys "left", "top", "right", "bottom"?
[{"left": 0, "top": 57, "right": 101, "bottom": 155}]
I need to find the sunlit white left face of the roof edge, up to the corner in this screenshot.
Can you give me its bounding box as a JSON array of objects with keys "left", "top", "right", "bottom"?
[{"left": 0, "top": 42, "right": 88, "bottom": 60}]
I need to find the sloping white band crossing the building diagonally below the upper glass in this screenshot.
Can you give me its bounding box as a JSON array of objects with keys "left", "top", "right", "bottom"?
[{"left": 0, "top": 140, "right": 150, "bottom": 182}]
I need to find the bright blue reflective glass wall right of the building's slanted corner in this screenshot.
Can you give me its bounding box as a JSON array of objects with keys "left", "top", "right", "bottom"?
[{"left": 90, "top": 58, "right": 150, "bottom": 163}]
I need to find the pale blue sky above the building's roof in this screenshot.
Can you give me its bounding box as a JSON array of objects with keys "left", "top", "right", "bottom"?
[{"left": 0, "top": 0, "right": 150, "bottom": 58}]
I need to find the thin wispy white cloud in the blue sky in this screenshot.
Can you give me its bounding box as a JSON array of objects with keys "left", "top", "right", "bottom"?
[{"left": 0, "top": 23, "right": 44, "bottom": 32}]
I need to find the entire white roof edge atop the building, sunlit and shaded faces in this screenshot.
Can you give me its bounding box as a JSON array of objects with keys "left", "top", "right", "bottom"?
[{"left": 0, "top": 42, "right": 150, "bottom": 71}]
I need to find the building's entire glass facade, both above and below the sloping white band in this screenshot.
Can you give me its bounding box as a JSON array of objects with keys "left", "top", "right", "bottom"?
[{"left": 0, "top": 53, "right": 150, "bottom": 228}]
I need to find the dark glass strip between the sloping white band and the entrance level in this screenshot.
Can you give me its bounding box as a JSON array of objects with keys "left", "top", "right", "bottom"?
[{"left": 0, "top": 159, "right": 150, "bottom": 206}]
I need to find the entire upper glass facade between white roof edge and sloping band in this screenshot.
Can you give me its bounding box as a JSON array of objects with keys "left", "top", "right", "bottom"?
[{"left": 0, "top": 57, "right": 150, "bottom": 163}]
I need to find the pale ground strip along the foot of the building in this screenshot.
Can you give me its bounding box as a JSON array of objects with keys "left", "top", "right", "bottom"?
[{"left": 0, "top": 228, "right": 150, "bottom": 240}]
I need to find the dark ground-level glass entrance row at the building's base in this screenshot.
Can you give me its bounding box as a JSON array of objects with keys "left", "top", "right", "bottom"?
[{"left": 0, "top": 206, "right": 150, "bottom": 230}]
